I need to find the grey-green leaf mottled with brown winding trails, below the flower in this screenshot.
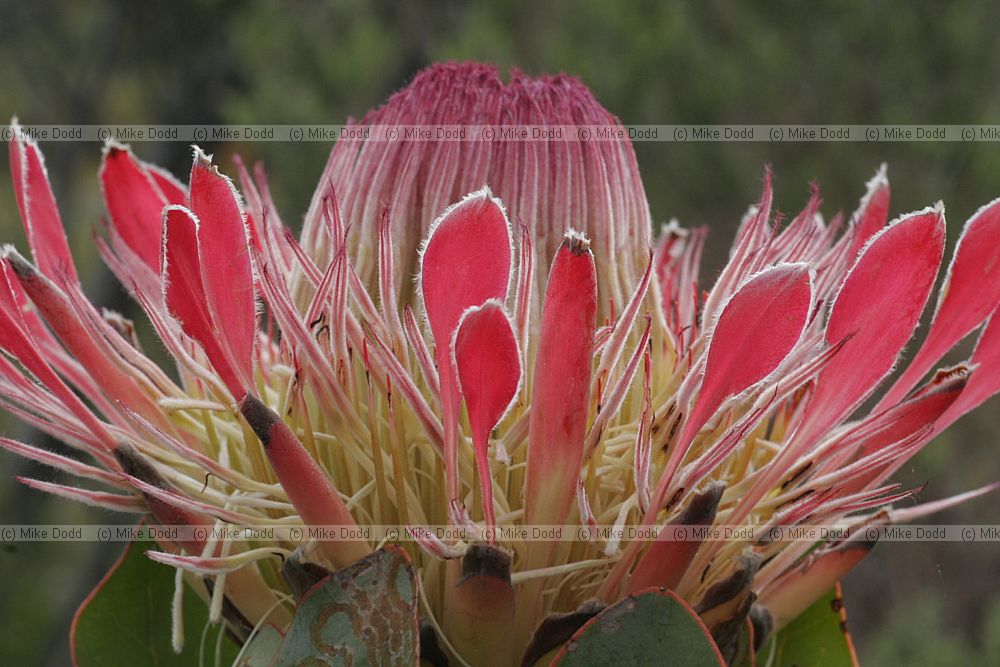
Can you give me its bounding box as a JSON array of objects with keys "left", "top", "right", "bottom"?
[{"left": 276, "top": 545, "right": 419, "bottom": 667}]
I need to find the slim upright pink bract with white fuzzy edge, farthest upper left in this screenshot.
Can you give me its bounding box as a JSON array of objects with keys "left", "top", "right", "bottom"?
[{"left": 10, "top": 124, "right": 77, "bottom": 282}]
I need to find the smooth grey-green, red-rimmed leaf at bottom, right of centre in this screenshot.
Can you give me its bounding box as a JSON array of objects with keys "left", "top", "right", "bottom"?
[{"left": 555, "top": 589, "right": 723, "bottom": 667}]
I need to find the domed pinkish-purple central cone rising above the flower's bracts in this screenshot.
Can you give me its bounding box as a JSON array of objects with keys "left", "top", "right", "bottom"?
[{"left": 302, "top": 64, "right": 652, "bottom": 322}]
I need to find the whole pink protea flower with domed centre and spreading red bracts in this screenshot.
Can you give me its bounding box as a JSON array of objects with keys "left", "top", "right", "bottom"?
[{"left": 0, "top": 65, "right": 1000, "bottom": 665}]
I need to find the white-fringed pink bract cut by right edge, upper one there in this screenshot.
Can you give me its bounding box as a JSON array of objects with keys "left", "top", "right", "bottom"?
[{"left": 879, "top": 199, "right": 1000, "bottom": 407}]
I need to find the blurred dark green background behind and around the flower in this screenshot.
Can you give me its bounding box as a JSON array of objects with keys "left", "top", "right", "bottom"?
[{"left": 0, "top": 0, "right": 1000, "bottom": 665}]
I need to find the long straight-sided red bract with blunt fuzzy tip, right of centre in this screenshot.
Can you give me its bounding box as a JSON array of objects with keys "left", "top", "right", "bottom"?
[{"left": 525, "top": 233, "right": 597, "bottom": 524}]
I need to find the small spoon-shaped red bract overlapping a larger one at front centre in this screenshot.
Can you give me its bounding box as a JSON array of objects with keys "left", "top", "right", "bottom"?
[{"left": 454, "top": 300, "right": 521, "bottom": 527}]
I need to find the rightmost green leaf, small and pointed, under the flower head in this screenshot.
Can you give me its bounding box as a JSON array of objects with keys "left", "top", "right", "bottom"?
[{"left": 758, "top": 584, "right": 858, "bottom": 667}]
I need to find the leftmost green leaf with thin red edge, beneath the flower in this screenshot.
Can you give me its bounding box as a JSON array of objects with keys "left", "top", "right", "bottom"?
[{"left": 70, "top": 540, "right": 239, "bottom": 667}]
